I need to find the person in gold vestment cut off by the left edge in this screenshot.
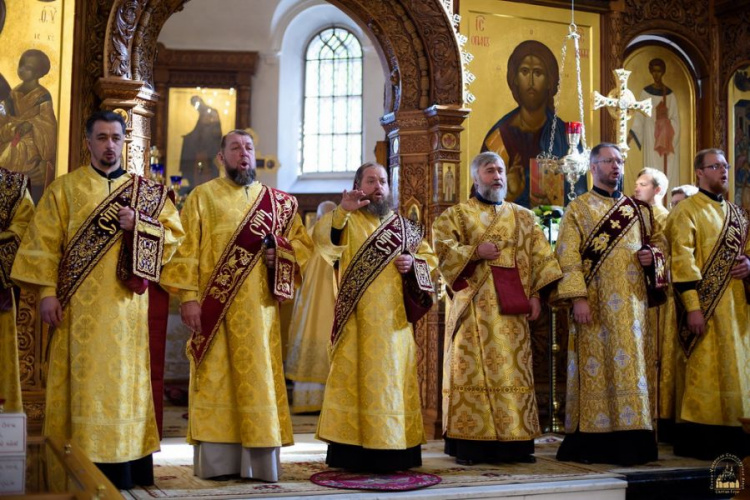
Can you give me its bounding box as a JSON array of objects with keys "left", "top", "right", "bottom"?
[{"left": 0, "top": 167, "right": 34, "bottom": 413}]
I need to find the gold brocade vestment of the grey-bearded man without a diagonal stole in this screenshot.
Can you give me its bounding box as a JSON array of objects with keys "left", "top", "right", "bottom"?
[{"left": 432, "top": 198, "right": 562, "bottom": 441}]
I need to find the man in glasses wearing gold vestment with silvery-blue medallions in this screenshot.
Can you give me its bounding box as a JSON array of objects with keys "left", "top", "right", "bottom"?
[{"left": 556, "top": 143, "right": 664, "bottom": 465}]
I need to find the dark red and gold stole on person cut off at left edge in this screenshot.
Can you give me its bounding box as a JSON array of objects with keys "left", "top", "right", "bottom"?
[{"left": 0, "top": 168, "right": 29, "bottom": 311}]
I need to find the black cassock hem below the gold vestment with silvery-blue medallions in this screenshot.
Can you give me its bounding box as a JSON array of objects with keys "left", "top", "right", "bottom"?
[{"left": 557, "top": 430, "right": 659, "bottom": 466}]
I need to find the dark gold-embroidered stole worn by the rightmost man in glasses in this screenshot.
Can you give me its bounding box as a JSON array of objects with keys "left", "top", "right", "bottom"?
[{"left": 675, "top": 201, "right": 749, "bottom": 357}]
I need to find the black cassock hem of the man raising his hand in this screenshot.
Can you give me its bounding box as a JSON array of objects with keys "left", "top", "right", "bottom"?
[{"left": 326, "top": 443, "right": 422, "bottom": 473}]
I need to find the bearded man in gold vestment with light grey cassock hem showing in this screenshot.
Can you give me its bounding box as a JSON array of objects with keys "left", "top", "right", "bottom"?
[{"left": 162, "top": 130, "right": 312, "bottom": 482}]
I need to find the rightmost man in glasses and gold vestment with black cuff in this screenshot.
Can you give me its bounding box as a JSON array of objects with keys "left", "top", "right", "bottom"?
[{"left": 667, "top": 149, "right": 750, "bottom": 460}]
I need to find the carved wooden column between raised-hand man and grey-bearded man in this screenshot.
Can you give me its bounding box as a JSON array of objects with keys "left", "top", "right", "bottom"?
[{"left": 382, "top": 106, "right": 469, "bottom": 439}]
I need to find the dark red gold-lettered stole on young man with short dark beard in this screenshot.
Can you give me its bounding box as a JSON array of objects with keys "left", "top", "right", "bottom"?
[{"left": 57, "top": 176, "right": 167, "bottom": 309}]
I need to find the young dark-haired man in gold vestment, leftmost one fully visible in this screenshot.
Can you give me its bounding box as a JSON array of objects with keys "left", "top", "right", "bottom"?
[{"left": 12, "top": 111, "right": 184, "bottom": 489}]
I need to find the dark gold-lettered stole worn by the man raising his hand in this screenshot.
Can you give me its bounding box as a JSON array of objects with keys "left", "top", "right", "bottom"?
[{"left": 331, "top": 214, "right": 434, "bottom": 347}]
